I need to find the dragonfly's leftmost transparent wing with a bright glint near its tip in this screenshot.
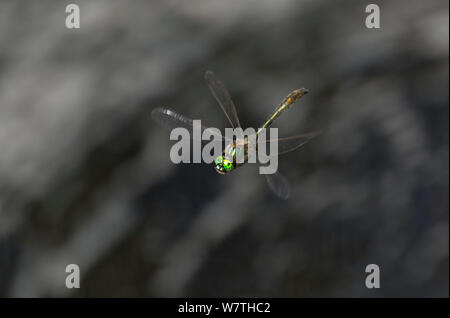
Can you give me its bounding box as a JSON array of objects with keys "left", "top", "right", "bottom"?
[{"left": 152, "top": 107, "right": 224, "bottom": 140}]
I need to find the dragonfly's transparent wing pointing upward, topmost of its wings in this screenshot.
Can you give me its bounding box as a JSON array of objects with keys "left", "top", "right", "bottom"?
[{"left": 205, "top": 71, "right": 241, "bottom": 128}]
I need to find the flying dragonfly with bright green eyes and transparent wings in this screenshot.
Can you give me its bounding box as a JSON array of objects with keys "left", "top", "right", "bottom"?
[{"left": 152, "top": 71, "right": 321, "bottom": 199}]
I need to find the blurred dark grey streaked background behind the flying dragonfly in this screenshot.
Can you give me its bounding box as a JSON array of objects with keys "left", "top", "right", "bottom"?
[{"left": 0, "top": 0, "right": 449, "bottom": 297}]
